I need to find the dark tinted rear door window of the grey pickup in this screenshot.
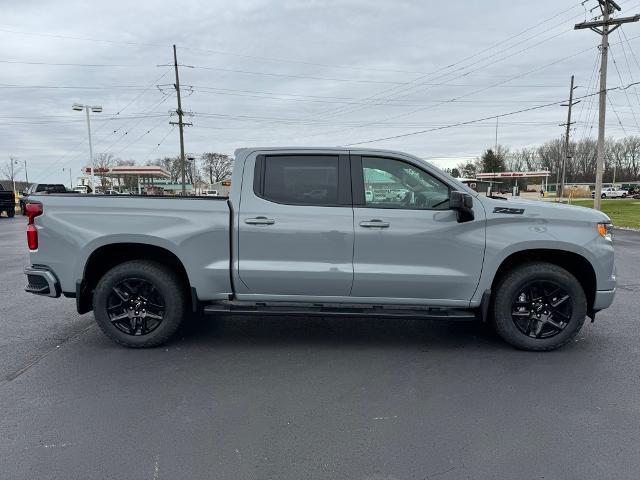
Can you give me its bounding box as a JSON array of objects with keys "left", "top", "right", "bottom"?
[{"left": 262, "top": 155, "right": 338, "bottom": 205}]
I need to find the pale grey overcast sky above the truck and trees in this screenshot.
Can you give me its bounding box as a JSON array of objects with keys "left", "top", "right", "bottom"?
[{"left": 0, "top": 0, "right": 640, "bottom": 183}]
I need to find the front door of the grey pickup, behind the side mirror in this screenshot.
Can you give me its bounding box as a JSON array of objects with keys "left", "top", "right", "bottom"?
[{"left": 351, "top": 155, "right": 485, "bottom": 305}]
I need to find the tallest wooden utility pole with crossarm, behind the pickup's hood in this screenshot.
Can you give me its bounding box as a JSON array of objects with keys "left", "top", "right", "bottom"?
[{"left": 574, "top": 0, "right": 640, "bottom": 210}]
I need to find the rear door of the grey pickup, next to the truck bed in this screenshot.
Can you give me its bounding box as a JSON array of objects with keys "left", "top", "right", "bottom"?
[{"left": 238, "top": 153, "right": 354, "bottom": 298}]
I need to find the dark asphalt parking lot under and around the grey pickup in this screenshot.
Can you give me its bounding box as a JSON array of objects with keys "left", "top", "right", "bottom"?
[{"left": 0, "top": 217, "right": 640, "bottom": 480}]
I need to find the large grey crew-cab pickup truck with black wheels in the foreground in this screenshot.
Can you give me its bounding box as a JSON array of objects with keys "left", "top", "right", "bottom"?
[{"left": 25, "top": 148, "right": 616, "bottom": 350}]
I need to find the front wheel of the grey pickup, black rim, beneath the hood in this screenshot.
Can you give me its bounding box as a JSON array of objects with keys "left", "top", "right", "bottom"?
[{"left": 493, "top": 262, "right": 587, "bottom": 351}]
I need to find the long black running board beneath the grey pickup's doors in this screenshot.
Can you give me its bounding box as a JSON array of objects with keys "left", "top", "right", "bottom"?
[{"left": 204, "top": 301, "right": 478, "bottom": 320}]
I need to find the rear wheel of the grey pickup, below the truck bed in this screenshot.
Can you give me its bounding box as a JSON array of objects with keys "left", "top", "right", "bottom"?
[{"left": 93, "top": 260, "right": 186, "bottom": 348}]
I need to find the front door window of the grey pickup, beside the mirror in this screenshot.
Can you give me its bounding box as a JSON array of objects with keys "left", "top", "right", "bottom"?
[{"left": 362, "top": 157, "right": 449, "bottom": 210}]
